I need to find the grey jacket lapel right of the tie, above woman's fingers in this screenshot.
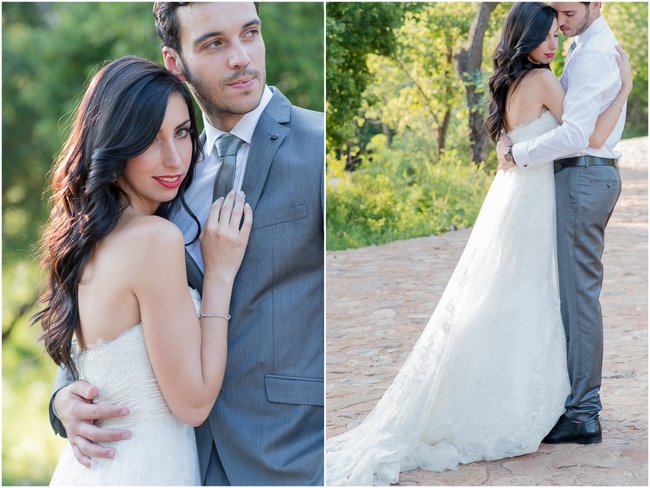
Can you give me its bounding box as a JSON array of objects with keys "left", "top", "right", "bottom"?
[{"left": 242, "top": 89, "right": 291, "bottom": 211}]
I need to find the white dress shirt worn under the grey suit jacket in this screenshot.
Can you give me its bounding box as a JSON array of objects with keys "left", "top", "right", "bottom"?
[{"left": 169, "top": 86, "right": 273, "bottom": 270}]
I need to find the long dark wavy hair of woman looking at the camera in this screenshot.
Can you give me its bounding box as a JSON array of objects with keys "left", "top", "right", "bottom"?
[{"left": 32, "top": 56, "right": 201, "bottom": 377}]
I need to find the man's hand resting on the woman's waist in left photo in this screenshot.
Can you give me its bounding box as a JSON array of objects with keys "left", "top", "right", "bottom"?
[{"left": 54, "top": 380, "right": 131, "bottom": 468}]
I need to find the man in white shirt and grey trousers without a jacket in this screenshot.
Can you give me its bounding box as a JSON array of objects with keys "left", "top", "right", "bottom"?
[{"left": 497, "top": 2, "right": 626, "bottom": 444}]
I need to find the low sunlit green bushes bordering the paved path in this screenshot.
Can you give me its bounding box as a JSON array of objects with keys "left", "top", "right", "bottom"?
[{"left": 327, "top": 134, "right": 491, "bottom": 250}]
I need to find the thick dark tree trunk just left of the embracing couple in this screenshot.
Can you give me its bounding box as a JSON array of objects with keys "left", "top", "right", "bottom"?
[{"left": 456, "top": 2, "right": 498, "bottom": 164}]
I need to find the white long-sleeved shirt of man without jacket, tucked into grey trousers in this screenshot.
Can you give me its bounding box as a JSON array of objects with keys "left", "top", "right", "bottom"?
[{"left": 512, "top": 17, "right": 627, "bottom": 168}]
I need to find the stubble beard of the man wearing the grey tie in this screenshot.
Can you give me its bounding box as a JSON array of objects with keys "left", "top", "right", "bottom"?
[{"left": 183, "top": 64, "right": 266, "bottom": 127}]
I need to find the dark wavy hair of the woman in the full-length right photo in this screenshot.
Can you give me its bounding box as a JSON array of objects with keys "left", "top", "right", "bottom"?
[{"left": 486, "top": 2, "right": 557, "bottom": 141}]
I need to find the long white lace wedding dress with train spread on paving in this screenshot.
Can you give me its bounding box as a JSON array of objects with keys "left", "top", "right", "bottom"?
[{"left": 326, "top": 112, "right": 570, "bottom": 485}]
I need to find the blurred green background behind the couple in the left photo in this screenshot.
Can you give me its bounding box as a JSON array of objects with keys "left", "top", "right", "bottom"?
[{"left": 2, "top": 2, "right": 324, "bottom": 485}]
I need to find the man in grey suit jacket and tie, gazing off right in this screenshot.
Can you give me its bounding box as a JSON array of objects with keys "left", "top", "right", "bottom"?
[{"left": 51, "top": 2, "right": 324, "bottom": 485}]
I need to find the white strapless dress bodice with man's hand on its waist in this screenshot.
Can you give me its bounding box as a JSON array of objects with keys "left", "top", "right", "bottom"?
[{"left": 50, "top": 290, "right": 201, "bottom": 486}]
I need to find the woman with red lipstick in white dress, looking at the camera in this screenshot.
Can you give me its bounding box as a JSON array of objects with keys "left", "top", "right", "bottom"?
[{"left": 34, "top": 56, "right": 252, "bottom": 485}]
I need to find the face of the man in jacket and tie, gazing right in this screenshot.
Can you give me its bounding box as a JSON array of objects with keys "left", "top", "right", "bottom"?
[{"left": 165, "top": 2, "right": 266, "bottom": 131}]
